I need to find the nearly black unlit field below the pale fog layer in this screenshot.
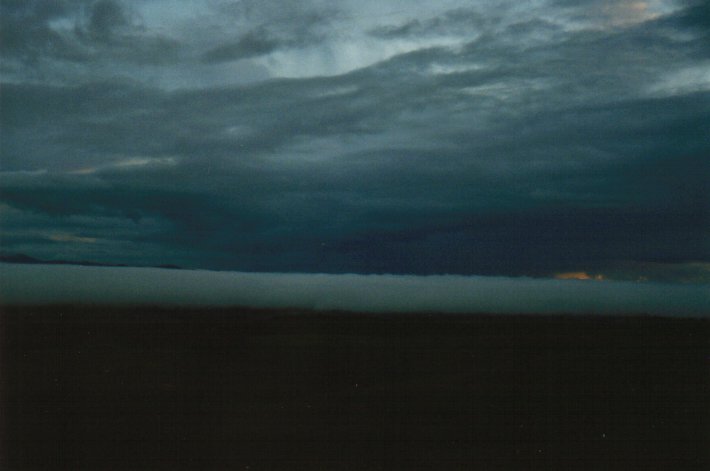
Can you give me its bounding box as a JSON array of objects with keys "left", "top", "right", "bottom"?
[{"left": 0, "top": 307, "right": 710, "bottom": 471}]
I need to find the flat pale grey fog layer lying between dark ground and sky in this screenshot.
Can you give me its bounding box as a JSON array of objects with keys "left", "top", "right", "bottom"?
[{"left": 0, "top": 264, "right": 710, "bottom": 316}]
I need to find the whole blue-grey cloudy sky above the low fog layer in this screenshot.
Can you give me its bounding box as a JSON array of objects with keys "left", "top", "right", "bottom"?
[{"left": 0, "top": 0, "right": 710, "bottom": 283}]
